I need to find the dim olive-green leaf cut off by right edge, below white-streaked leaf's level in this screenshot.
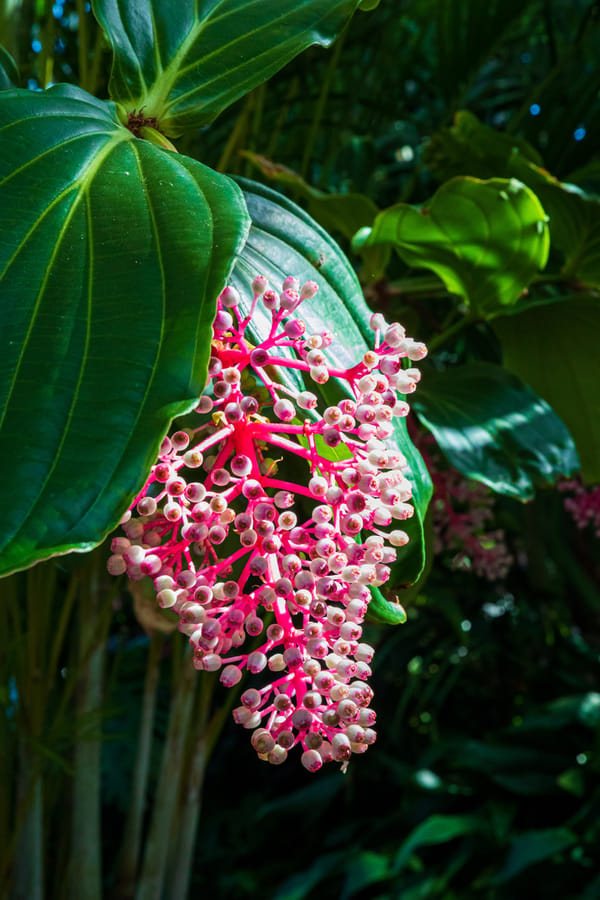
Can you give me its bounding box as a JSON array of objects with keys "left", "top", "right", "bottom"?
[{"left": 494, "top": 295, "right": 600, "bottom": 484}]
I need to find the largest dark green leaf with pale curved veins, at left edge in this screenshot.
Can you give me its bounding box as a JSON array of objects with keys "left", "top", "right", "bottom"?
[{"left": 0, "top": 86, "right": 247, "bottom": 574}]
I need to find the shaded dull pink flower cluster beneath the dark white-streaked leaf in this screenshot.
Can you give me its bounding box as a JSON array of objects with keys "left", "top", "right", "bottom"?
[{"left": 429, "top": 466, "right": 514, "bottom": 581}]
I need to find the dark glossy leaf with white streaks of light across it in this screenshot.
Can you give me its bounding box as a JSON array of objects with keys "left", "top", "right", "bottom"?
[{"left": 413, "top": 363, "right": 579, "bottom": 500}]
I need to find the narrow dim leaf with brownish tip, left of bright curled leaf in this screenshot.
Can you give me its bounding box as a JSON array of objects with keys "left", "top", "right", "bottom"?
[{"left": 242, "top": 151, "right": 390, "bottom": 281}]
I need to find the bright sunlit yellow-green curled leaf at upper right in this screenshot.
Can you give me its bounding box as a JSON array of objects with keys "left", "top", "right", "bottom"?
[{"left": 354, "top": 177, "right": 549, "bottom": 318}]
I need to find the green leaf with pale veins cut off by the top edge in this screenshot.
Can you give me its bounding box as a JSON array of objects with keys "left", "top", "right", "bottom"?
[{"left": 93, "top": 0, "right": 358, "bottom": 135}]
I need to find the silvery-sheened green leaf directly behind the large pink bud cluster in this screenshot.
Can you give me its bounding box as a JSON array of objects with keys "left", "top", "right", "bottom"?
[{"left": 233, "top": 179, "right": 431, "bottom": 583}]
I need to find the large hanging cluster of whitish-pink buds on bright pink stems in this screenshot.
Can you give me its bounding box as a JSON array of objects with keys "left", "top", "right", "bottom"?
[{"left": 108, "top": 276, "right": 426, "bottom": 771}]
